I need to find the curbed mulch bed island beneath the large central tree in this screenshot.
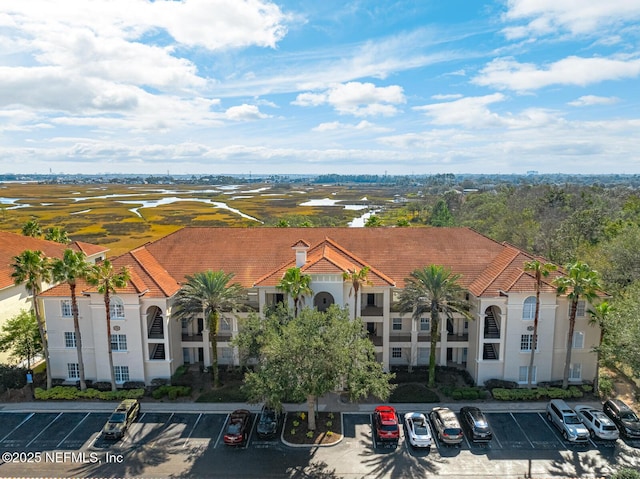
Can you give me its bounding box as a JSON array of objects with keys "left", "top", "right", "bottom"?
[{"left": 283, "top": 412, "right": 342, "bottom": 446}]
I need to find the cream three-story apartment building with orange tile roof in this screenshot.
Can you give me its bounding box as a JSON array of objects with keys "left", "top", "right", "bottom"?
[{"left": 42, "top": 227, "right": 599, "bottom": 384}]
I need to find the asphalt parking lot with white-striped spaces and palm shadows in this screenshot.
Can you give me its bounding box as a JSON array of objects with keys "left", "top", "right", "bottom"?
[{"left": 0, "top": 409, "right": 640, "bottom": 478}]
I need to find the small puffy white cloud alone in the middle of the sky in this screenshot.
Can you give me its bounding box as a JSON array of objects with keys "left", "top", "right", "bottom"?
[{"left": 292, "top": 82, "right": 406, "bottom": 116}]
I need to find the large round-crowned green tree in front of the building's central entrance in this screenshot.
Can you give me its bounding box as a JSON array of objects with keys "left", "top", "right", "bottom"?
[{"left": 239, "top": 305, "right": 393, "bottom": 430}]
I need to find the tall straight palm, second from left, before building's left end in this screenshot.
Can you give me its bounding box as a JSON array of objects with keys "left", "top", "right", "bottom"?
[{"left": 51, "top": 249, "right": 90, "bottom": 391}]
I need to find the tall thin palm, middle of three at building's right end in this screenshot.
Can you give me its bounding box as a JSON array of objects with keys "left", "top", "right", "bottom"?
[{"left": 554, "top": 261, "right": 600, "bottom": 389}]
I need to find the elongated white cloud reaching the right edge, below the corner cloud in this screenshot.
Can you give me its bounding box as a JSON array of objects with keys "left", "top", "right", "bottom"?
[{"left": 472, "top": 56, "right": 640, "bottom": 91}]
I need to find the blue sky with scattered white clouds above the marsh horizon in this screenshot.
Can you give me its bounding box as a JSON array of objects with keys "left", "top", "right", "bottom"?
[{"left": 0, "top": 0, "right": 640, "bottom": 175}]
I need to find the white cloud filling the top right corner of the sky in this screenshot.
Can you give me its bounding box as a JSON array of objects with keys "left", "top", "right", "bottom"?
[{"left": 504, "top": 0, "right": 640, "bottom": 39}]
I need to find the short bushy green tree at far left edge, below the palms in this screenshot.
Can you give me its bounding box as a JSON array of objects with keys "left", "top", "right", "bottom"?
[{"left": 0, "top": 310, "right": 42, "bottom": 369}]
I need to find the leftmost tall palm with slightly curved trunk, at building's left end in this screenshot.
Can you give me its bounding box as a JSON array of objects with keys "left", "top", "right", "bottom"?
[{"left": 11, "top": 250, "right": 51, "bottom": 389}]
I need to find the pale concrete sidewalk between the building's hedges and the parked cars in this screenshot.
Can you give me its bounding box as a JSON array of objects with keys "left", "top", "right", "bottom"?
[{"left": 0, "top": 393, "right": 602, "bottom": 413}]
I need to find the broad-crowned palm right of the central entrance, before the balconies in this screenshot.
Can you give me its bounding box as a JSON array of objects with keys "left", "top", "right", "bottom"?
[{"left": 399, "top": 265, "right": 472, "bottom": 387}]
